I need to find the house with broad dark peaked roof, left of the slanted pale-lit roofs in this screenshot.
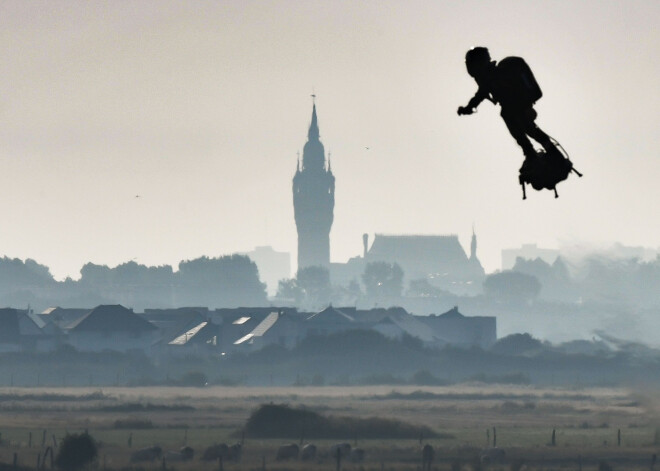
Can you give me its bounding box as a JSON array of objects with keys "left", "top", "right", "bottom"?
[{"left": 67, "top": 304, "right": 159, "bottom": 352}]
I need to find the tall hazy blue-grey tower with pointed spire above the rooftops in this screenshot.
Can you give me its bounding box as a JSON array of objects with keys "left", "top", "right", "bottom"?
[{"left": 293, "top": 103, "right": 335, "bottom": 270}]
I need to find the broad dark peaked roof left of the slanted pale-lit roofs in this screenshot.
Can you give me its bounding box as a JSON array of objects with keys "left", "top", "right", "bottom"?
[{"left": 71, "top": 304, "right": 156, "bottom": 332}]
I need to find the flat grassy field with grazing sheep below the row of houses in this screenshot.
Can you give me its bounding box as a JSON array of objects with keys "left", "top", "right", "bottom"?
[{"left": 0, "top": 384, "right": 660, "bottom": 471}]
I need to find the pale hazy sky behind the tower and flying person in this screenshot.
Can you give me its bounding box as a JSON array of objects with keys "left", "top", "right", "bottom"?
[{"left": 0, "top": 0, "right": 660, "bottom": 278}]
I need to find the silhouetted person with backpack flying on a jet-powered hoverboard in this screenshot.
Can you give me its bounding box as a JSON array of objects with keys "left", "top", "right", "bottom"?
[{"left": 458, "top": 47, "right": 581, "bottom": 199}]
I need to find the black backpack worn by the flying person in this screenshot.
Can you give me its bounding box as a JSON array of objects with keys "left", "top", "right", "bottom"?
[{"left": 497, "top": 57, "right": 543, "bottom": 107}]
